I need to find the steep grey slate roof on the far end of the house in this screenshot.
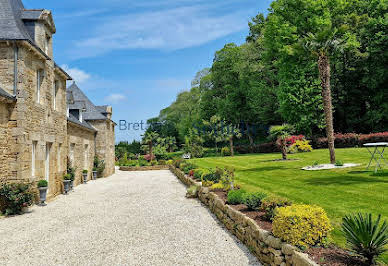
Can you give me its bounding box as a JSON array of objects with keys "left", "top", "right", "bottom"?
[{"left": 67, "top": 82, "right": 108, "bottom": 120}]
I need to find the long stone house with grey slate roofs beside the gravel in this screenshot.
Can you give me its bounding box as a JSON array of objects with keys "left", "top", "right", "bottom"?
[{"left": 0, "top": 0, "right": 115, "bottom": 200}]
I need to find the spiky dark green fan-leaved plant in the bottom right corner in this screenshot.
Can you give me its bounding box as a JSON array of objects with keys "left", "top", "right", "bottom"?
[{"left": 342, "top": 213, "right": 388, "bottom": 265}]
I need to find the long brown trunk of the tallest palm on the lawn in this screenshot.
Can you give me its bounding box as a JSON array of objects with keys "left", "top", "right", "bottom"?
[{"left": 318, "top": 54, "right": 335, "bottom": 164}]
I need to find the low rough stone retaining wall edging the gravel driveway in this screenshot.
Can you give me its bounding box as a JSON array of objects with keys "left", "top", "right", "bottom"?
[{"left": 170, "top": 165, "right": 318, "bottom": 266}]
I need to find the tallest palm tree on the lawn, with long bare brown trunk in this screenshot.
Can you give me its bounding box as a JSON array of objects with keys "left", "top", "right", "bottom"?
[{"left": 303, "top": 30, "right": 343, "bottom": 164}]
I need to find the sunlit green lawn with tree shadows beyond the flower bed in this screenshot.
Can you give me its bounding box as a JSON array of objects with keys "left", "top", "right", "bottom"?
[{"left": 192, "top": 148, "right": 388, "bottom": 262}]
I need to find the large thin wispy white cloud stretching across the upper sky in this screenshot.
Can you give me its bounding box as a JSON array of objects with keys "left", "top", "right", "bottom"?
[{"left": 72, "top": 6, "right": 247, "bottom": 58}]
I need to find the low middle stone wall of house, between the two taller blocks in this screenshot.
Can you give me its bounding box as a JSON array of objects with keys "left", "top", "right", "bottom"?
[{"left": 67, "top": 122, "right": 95, "bottom": 186}]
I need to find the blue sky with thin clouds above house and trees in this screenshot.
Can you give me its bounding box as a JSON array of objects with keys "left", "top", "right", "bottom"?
[{"left": 23, "top": 0, "right": 271, "bottom": 141}]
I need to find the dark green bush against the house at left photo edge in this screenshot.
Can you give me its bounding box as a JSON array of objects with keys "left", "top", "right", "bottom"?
[{"left": 0, "top": 183, "right": 34, "bottom": 215}]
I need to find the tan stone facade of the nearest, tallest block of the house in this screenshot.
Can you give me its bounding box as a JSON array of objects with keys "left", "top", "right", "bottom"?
[{"left": 0, "top": 42, "right": 67, "bottom": 197}]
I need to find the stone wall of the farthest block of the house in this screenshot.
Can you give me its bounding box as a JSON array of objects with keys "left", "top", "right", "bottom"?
[{"left": 88, "top": 120, "right": 115, "bottom": 177}]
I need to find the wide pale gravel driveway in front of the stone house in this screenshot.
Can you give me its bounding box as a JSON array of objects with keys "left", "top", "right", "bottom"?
[{"left": 0, "top": 171, "right": 260, "bottom": 266}]
